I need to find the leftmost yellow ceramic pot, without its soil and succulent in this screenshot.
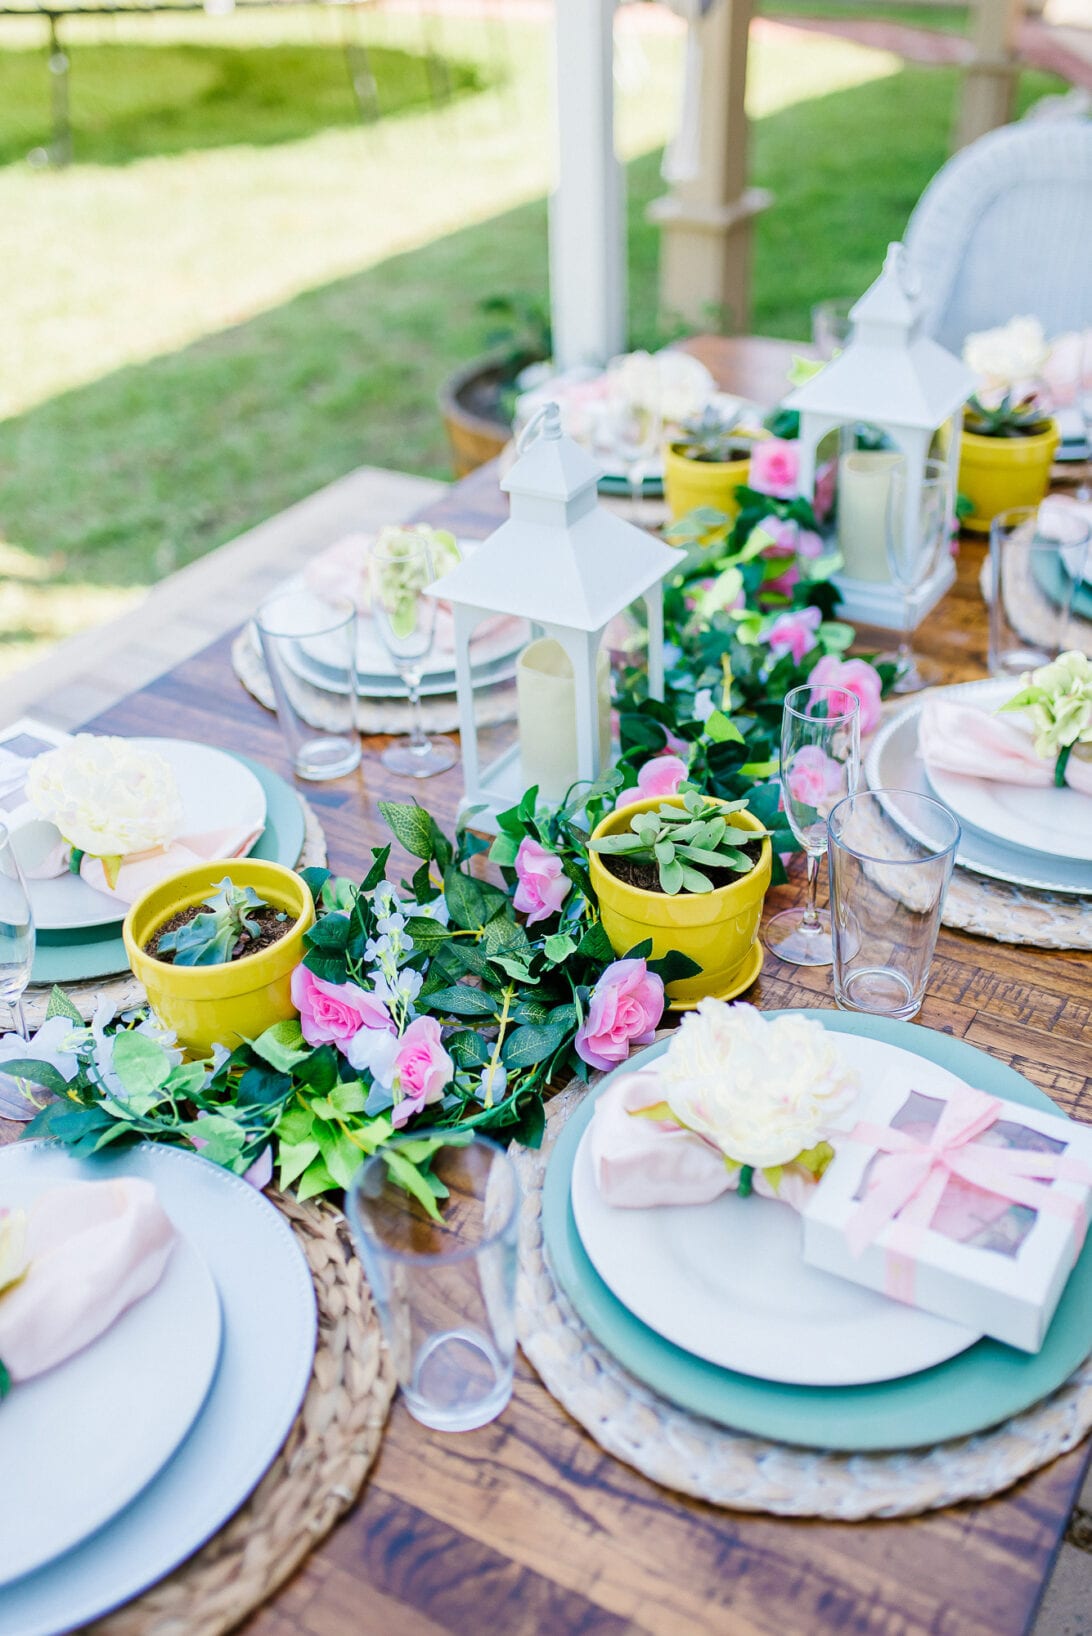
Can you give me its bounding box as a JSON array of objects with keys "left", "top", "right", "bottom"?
[{"left": 123, "top": 857, "right": 314, "bottom": 1057}]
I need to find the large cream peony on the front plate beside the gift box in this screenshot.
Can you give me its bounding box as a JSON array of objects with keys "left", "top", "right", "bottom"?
[{"left": 660, "top": 1000, "right": 858, "bottom": 1170}]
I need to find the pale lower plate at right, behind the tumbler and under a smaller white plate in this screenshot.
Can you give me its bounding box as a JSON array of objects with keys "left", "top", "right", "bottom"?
[{"left": 864, "top": 682, "right": 1092, "bottom": 897}]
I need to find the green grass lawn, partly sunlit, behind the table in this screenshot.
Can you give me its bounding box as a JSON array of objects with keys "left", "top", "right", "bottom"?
[{"left": 0, "top": 6, "right": 1054, "bottom": 669}]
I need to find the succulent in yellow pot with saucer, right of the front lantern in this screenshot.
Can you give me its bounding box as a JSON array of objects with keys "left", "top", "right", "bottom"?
[{"left": 588, "top": 789, "right": 773, "bottom": 1006}]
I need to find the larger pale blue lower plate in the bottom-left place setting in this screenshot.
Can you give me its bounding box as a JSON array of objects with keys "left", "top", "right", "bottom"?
[{"left": 0, "top": 1142, "right": 314, "bottom": 1636}]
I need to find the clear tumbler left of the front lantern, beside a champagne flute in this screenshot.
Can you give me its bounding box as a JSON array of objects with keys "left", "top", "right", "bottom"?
[{"left": 257, "top": 591, "right": 360, "bottom": 784}]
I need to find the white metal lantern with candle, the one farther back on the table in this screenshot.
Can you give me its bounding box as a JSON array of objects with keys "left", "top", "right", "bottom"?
[{"left": 784, "top": 244, "right": 977, "bottom": 630}]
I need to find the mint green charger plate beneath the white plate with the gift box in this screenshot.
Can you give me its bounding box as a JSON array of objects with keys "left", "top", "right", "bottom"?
[{"left": 542, "top": 1009, "right": 1092, "bottom": 1451}]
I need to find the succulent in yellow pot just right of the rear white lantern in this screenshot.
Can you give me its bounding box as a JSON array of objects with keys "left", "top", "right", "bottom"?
[{"left": 959, "top": 391, "right": 1059, "bottom": 533}]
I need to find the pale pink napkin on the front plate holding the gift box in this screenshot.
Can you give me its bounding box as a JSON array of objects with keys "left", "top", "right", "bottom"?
[{"left": 591, "top": 1068, "right": 810, "bottom": 1211}]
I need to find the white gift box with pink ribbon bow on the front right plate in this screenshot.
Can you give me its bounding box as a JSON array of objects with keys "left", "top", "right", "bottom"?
[{"left": 804, "top": 1081, "right": 1092, "bottom": 1351}]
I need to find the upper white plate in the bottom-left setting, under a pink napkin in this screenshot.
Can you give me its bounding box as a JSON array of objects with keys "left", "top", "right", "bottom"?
[{"left": 0, "top": 1142, "right": 221, "bottom": 1583}]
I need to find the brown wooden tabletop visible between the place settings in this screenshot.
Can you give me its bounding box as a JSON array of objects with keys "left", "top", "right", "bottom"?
[{"left": 10, "top": 339, "right": 1092, "bottom": 1636}]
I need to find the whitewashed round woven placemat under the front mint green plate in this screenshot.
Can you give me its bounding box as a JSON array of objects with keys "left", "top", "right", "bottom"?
[{"left": 512, "top": 1086, "right": 1092, "bottom": 1521}]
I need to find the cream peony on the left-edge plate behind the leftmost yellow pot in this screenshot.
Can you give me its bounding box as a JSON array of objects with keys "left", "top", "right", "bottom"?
[{"left": 26, "top": 733, "right": 183, "bottom": 857}]
